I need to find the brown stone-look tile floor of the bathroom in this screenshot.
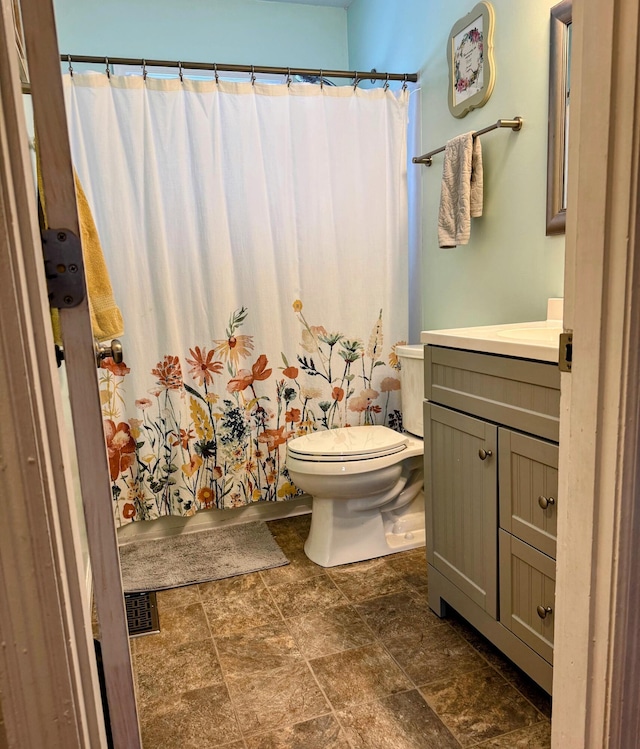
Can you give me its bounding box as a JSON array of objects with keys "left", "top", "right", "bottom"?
[{"left": 132, "top": 516, "right": 551, "bottom": 749}]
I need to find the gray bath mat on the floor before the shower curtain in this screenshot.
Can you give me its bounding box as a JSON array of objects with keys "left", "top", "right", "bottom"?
[{"left": 120, "top": 521, "right": 289, "bottom": 593}]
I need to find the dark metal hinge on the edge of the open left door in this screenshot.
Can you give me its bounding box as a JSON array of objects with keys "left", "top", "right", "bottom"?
[{"left": 42, "top": 229, "right": 86, "bottom": 309}]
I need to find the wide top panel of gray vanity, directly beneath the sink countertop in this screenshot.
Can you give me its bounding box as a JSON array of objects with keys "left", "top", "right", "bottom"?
[{"left": 424, "top": 346, "right": 560, "bottom": 442}]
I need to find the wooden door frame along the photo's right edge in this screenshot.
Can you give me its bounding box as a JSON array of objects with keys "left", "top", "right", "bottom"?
[{"left": 552, "top": 0, "right": 640, "bottom": 749}]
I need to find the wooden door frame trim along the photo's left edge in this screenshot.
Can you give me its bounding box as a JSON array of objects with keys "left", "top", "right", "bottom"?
[{"left": 0, "top": 0, "right": 106, "bottom": 749}]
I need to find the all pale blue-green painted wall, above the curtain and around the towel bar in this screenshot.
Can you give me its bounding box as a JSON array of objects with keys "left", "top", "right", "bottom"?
[{"left": 55, "top": 0, "right": 564, "bottom": 329}]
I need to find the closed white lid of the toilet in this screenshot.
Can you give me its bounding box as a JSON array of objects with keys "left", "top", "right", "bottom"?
[{"left": 287, "top": 426, "right": 408, "bottom": 462}]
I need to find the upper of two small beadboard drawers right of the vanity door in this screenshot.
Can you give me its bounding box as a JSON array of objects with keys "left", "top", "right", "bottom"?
[{"left": 498, "top": 429, "right": 558, "bottom": 559}]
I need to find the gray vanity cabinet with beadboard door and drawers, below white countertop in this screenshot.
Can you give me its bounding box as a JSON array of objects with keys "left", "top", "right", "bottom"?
[{"left": 424, "top": 345, "right": 560, "bottom": 692}]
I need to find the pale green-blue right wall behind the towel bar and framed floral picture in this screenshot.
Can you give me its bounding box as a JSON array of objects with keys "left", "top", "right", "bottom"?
[{"left": 348, "top": 0, "right": 564, "bottom": 329}]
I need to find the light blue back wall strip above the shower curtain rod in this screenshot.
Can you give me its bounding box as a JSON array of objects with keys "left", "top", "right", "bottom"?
[{"left": 55, "top": 0, "right": 348, "bottom": 69}]
